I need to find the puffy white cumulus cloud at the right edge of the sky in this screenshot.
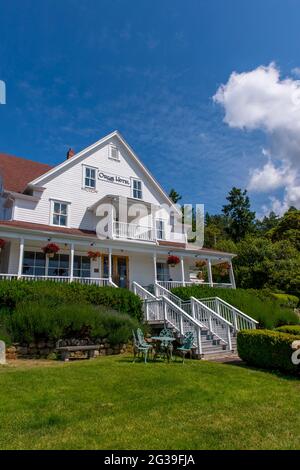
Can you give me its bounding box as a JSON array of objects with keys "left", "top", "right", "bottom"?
[{"left": 213, "top": 63, "right": 300, "bottom": 213}]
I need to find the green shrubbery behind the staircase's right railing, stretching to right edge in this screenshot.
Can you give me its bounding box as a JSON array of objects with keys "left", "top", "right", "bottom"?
[{"left": 172, "top": 285, "right": 299, "bottom": 329}]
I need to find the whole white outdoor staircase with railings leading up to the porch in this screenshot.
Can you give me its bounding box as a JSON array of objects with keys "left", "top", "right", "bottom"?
[{"left": 133, "top": 282, "right": 257, "bottom": 359}]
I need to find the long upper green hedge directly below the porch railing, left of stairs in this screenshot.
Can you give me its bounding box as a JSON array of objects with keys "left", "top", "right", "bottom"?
[{"left": 0, "top": 281, "right": 143, "bottom": 320}]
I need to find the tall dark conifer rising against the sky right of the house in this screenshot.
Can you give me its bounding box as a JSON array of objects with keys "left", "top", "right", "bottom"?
[{"left": 222, "top": 187, "right": 255, "bottom": 242}]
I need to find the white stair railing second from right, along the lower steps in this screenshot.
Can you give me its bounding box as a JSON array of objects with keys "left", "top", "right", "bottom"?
[{"left": 191, "top": 297, "right": 234, "bottom": 350}]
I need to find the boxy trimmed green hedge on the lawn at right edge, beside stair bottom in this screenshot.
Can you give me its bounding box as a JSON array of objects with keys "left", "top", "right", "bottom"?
[{"left": 237, "top": 330, "right": 300, "bottom": 374}]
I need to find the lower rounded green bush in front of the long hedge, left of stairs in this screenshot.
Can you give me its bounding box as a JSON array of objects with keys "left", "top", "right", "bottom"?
[{"left": 4, "top": 300, "right": 139, "bottom": 344}]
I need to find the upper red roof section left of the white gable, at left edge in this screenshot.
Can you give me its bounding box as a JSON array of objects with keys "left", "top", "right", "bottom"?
[{"left": 0, "top": 153, "right": 52, "bottom": 193}]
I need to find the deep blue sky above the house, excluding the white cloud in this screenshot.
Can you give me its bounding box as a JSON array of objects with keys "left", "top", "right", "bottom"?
[{"left": 0, "top": 0, "right": 300, "bottom": 212}]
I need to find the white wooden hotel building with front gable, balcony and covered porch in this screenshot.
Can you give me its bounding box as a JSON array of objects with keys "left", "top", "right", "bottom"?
[{"left": 0, "top": 131, "right": 235, "bottom": 287}]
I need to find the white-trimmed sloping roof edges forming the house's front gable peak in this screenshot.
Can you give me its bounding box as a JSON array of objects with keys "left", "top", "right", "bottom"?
[{"left": 30, "top": 131, "right": 181, "bottom": 213}]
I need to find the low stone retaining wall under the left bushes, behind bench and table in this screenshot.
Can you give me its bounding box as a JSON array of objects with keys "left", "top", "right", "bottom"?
[{"left": 6, "top": 338, "right": 130, "bottom": 359}]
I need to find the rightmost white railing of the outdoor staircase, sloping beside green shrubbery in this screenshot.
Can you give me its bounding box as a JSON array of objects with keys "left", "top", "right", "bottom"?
[{"left": 201, "top": 297, "right": 258, "bottom": 331}]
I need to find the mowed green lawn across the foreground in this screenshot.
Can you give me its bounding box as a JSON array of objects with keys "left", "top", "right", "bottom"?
[{"left": 0, "top": 356, "right": 300, "bottom": 450}]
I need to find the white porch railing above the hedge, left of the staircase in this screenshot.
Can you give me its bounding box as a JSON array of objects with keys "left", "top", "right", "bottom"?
[{"left": 0, "top": 274, "right": 118, "bottom": 287}]
